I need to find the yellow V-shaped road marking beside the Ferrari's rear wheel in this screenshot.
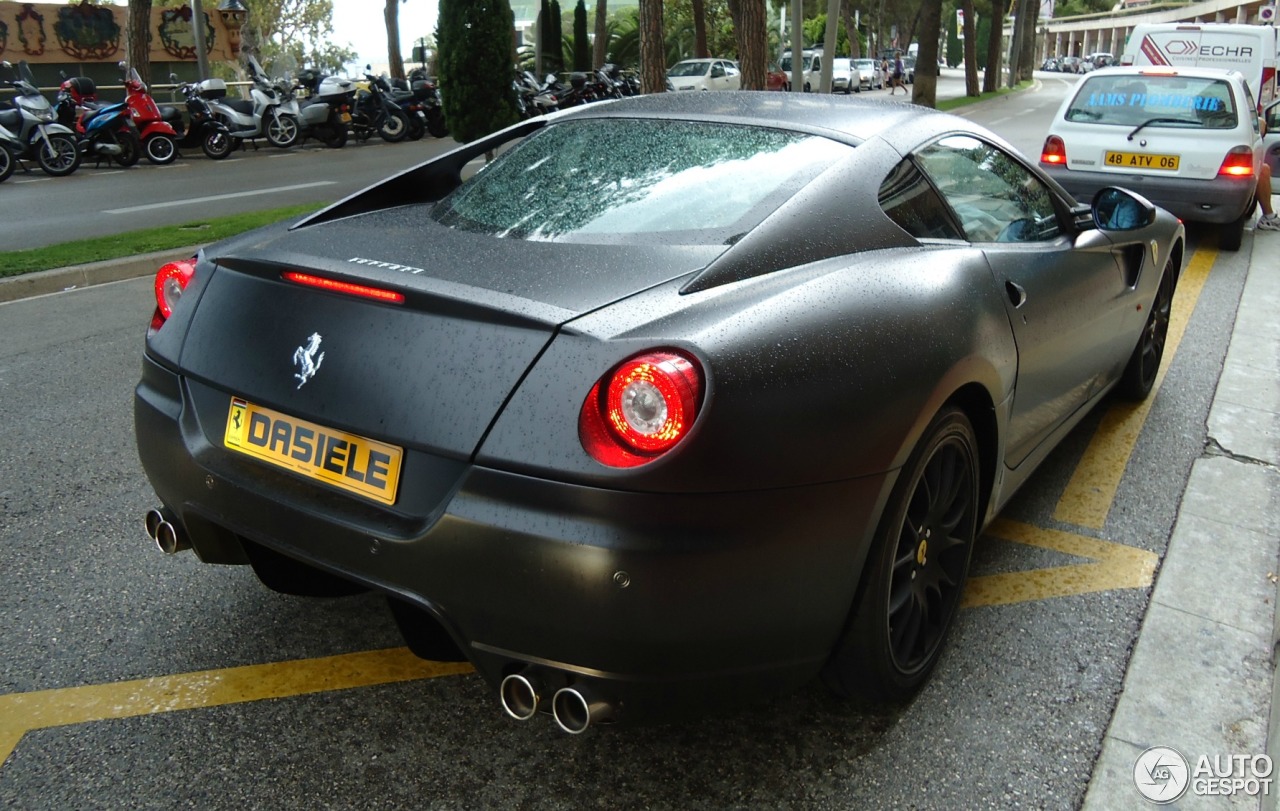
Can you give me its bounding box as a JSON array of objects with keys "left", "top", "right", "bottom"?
[{"left": 960, "top": 518, "right": 1160, "bottom": 608}]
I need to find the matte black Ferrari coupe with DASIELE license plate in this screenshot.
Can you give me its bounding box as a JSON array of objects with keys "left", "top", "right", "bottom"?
[{"left": 136, "top": 93, "right": 1184, "bottom": 732}]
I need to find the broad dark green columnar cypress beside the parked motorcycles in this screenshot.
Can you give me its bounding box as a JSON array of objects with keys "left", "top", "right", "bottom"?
[{"left": 436, "top": 0, "right": 520, "bottom": 143}]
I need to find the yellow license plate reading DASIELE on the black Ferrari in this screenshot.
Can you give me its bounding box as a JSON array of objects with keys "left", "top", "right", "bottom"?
[{"left": 223, "top": 397, "right": 404, "bottom": 504}]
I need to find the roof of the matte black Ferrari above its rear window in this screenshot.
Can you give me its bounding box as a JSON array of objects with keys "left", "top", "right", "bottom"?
[{"left": 557, "top": 91, "right": 952, "bottom": 145}]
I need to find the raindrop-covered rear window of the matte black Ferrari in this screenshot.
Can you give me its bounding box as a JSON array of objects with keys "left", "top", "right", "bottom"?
[{"left": 431, "top": 118, "right": 854, "bottom": 244}]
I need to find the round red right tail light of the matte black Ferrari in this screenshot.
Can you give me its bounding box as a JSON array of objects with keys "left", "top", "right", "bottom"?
[{"left": 579, "top": 352, "right": 703, "bottom": 467}]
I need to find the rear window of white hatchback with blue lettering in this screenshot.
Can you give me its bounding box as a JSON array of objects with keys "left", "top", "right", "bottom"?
[{"left": 1066, "top": 73, "right": 1239, "bottom": 129}]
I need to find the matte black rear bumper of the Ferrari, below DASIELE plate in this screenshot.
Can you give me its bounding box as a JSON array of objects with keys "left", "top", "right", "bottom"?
[{"left": 134, "top": 361, "right": 890, "bottom": 720}]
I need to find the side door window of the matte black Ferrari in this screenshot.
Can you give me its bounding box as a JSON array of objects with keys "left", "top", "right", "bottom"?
[{"left": 918, "top": 136, "right": 1060, "bottom": 242}]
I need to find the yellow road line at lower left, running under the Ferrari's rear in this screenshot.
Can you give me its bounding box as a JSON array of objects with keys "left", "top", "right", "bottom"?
[{"left": 0, "top": 647, "right": 472, "bottom": 764}]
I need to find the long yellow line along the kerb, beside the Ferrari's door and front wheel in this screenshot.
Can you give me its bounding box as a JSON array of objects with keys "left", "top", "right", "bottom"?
[{"left": 1053, "top": 248, "right": 1217, "bottom": 530}]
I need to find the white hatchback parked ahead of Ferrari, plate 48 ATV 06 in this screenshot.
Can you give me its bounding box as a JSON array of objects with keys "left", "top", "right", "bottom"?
[{"left": 1041, "top": 67, "right": 1262, "bottom": 251}]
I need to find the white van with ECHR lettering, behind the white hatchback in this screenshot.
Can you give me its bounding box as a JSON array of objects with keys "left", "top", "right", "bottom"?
[{"left": 1120, "top": 23, "right": 1277, "bottom": 113}]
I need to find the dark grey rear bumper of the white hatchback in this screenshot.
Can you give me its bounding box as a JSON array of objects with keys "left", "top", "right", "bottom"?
[{"left": 1041, "top": 164, "right": 1257, "bottom": 225}]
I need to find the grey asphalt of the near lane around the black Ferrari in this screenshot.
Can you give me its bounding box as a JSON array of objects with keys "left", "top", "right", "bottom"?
[{"left": 0, "top": 77, "right": 1252, "bottom": 810}]
